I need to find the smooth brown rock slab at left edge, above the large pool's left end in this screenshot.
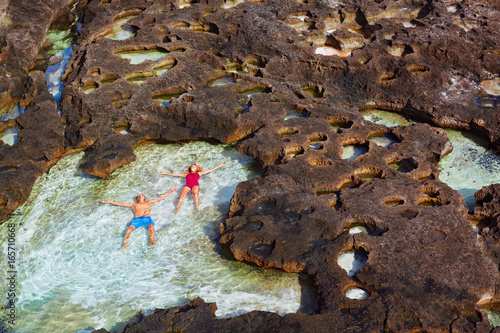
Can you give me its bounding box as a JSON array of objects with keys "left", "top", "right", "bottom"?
[{"left": 0, "top": 72, "right": 65, "bottom": 220}]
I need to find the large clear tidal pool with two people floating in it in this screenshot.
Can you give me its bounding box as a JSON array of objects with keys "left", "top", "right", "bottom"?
[{"left": 0, "top": 142, "right": 301, "bottom": 332}]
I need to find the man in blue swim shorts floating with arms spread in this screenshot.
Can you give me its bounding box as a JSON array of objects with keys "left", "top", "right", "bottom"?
[{"left": 102, "top": 188, "right": 177, "bottom": 250}]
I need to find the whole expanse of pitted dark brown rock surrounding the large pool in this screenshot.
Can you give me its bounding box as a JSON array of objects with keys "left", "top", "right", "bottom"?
[{"left": 0, "top": 0, "right": 500, "bottom": 332}]
